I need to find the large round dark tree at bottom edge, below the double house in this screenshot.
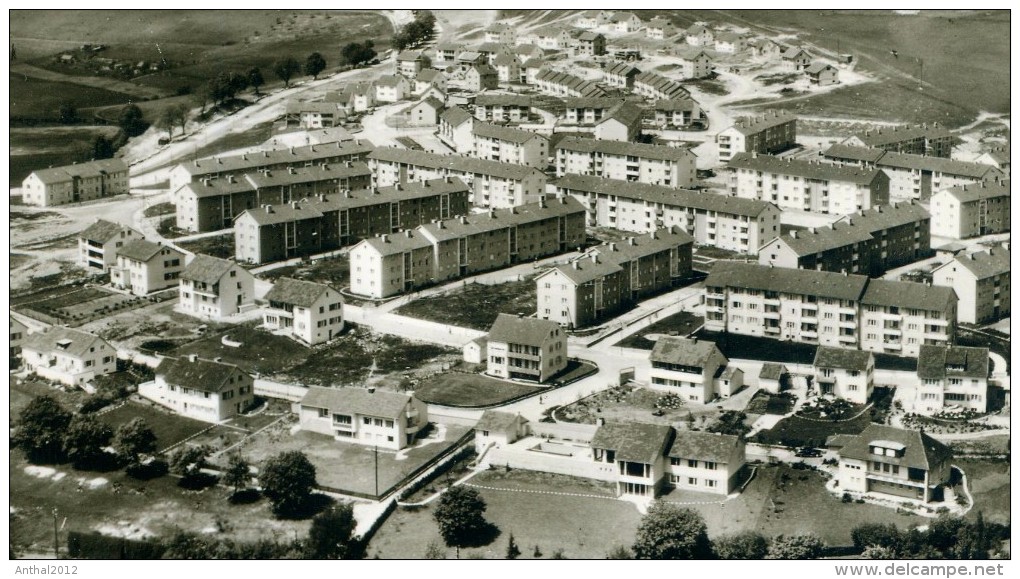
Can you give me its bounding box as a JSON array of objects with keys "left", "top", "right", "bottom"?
[{"left": 633, "top": 501, "right": 712, "bottom": 559}]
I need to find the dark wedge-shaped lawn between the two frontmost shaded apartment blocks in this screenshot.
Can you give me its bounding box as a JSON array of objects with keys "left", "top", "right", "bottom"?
[{"left": 395, "top": 275, "right": 538, "bottom": 330}]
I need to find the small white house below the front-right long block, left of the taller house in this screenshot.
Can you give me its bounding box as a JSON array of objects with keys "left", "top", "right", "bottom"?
[{"left": 811, "top": 346, "right": 875, "bottom": 404}]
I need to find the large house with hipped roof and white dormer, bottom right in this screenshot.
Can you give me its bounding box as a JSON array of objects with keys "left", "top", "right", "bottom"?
[{"left": 836, "top": 424, "right": 953, "bottom": 503}]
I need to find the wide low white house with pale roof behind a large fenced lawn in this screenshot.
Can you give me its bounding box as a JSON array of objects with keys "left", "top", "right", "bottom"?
[{"left": 298, "top": 386, "right": 428, "bottom": 451}]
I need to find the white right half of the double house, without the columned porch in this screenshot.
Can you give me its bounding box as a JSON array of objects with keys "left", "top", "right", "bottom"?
[{"left": 666, "top": 430, "right": 747, "bottom": 495}]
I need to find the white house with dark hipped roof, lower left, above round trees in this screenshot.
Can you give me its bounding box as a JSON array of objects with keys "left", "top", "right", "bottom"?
[{"left": 138, "top": 355, "right": 255, "bottom": 423}]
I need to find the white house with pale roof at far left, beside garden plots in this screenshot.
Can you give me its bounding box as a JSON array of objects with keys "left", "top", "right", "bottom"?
[{"left": 21, "top": 326, "right": 117, "bottom": 386}]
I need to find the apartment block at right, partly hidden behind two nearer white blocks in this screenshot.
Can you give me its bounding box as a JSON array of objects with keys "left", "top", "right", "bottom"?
[{"left": 823, "top": 145, "right": 1006, "bottom": 201}]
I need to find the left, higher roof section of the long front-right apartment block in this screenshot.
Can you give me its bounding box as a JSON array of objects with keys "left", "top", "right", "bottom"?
[{"left": 705, "top": 261, "right": 868, "bottom": 301}]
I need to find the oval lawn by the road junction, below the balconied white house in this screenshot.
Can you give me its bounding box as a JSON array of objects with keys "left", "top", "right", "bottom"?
[{"left": 414, "top": 373, "right": 547, "bottom": 408}]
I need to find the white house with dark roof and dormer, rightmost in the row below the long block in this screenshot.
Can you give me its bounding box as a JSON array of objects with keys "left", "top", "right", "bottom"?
[{"left": 914, "top": 346, "right": 991, "bottom": 416}]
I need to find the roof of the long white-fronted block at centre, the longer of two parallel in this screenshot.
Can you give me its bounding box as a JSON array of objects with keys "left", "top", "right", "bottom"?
[{"left": 555, "top": 173, "right": 772, "bottom": 217}]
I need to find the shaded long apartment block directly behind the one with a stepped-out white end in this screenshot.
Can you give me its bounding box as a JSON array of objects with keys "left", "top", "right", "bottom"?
[{"left": 234, "top": 177, "right": 470, "bottom": 263}]
